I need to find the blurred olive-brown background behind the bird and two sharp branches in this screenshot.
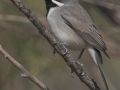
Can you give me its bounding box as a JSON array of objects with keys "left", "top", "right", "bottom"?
[{"left": 0, "top": 0, "right": 120, "bottom": 90}]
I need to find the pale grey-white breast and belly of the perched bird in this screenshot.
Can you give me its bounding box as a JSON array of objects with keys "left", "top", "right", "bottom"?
[{"left": 47, "top": 8, "right": 85, "bottom": 50}]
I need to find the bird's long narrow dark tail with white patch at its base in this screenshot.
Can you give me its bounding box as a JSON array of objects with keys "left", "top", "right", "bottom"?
[{"left": 88, "top": 49, "right": 109, "bottom": 90}]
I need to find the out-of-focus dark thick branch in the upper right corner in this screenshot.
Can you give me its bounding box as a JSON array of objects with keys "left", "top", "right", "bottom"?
[{"left": 83, "top": 0, "right": 120, "bottom": 26}]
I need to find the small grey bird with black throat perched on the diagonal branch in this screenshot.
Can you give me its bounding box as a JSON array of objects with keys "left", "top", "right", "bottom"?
[{"left": 45, "top": 0, "right": 110, "bottom": 90}]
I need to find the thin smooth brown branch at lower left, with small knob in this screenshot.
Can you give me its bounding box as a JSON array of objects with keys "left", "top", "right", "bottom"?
[{"left": 0, "top": 45, "right": 49, "bottom": 90}]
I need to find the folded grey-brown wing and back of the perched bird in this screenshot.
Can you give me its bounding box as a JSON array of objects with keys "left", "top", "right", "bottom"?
[{"left": 60, "top": 4, "right": 109, "bottom": 57}]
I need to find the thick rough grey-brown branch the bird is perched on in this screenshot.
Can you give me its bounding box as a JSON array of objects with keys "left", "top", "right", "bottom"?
[{"left": 7, "top": 0, "right": 101, "bottom": 90}]
